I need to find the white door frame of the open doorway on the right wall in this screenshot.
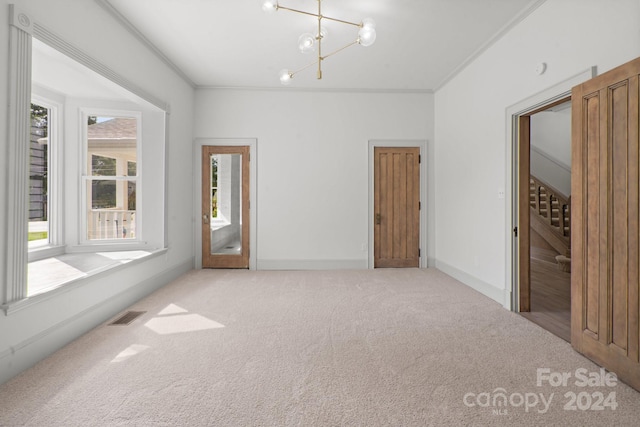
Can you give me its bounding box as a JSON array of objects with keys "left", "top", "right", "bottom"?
[{"left": 503, "top": 66, "right": 597, "bottom": 312}]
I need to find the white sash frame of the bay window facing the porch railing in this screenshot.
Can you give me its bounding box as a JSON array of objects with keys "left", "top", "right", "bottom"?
[{"left": 78, "top": 107, "right": 144, "bottom": 247}]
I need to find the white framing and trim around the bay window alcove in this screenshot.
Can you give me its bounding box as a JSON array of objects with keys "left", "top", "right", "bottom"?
[{"left": 0, "top": 4, "right": 171, "bottom": 310}]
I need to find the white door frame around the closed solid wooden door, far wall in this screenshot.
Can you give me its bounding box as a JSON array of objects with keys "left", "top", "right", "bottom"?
[{"left": 363, "top": 139, "right": 428, "bottom": 269}]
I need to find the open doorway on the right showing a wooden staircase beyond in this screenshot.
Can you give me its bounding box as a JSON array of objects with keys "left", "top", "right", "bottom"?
[{"left": 518, "top": 96, "right": 571, "bottom": 341}]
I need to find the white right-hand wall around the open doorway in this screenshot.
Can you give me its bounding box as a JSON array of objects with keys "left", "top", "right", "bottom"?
[{"left": 435, "top": 0, "right": 640, "bottom": 302}]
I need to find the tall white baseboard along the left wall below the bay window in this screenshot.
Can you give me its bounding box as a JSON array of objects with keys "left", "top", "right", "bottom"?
[{"left": 0, "top": 257, "right": 194, "bottom": 384}]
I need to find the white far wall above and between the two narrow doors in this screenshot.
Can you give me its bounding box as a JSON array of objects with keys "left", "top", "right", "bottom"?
[{"left": 195, "top": 89, "right": 433, "bottom": 268}]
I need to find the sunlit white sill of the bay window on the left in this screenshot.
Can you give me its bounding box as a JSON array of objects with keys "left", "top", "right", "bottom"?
[{"left": 0, "top": 249, "right": 167, "bottom": 316}]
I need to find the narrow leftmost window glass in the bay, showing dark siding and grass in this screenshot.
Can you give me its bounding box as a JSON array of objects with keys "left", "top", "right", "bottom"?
[{"left": 28, "top": 103, "right": 50, "bottom": 247}]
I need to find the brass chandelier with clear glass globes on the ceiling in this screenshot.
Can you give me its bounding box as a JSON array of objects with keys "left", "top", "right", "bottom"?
[{"left": 262, "top": 0, "right": 376, "bottom": 85}]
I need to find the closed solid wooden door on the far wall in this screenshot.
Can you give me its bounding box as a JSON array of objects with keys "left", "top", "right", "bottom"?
[{"left": 373, "top": 147, "right": 420, "bottom": 268}]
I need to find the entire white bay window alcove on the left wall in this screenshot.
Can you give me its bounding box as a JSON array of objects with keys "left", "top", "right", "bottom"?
[{"left": 0, "top": 13, "right": 169, "bottom": 306}]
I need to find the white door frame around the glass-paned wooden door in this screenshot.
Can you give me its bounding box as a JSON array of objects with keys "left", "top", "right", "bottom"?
[{"left": 192, "top": 138, "right": 258, "bottom": 270}]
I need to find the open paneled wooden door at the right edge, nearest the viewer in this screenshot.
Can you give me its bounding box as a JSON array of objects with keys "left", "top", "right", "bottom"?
[{"left": 571, "top": 58, "right": 640, "bottom": 390}]
